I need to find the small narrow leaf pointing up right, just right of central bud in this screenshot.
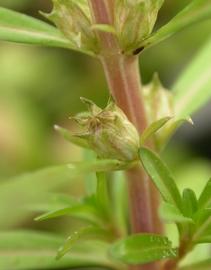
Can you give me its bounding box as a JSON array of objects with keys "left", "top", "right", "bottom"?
[{"left": 140, "top": 117, "right": 171, "bottom": 145}]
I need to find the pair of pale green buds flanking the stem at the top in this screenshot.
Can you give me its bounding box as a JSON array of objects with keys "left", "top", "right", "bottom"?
[{"left": 45, "top": 0, "right": 164, "bottom": 55}]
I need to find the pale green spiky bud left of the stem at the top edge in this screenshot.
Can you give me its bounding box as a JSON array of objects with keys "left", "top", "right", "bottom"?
[{"left": 46, "top": 0, "right": 98, "bottom": 53}]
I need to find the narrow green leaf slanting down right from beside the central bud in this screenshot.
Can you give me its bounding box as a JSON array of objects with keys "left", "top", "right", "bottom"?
[{"left": 139, "top": 147, "right": 182, "bottom": 211}]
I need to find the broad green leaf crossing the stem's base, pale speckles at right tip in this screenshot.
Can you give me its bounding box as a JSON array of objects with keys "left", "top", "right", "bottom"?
[{"left": 110, "top": 234, "right": 177, "bottom": 264}]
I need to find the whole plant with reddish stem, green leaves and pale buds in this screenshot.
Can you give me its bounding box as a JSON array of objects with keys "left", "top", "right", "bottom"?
[{"left": 0, "top": 0, "right": 211, "bottom": 270}]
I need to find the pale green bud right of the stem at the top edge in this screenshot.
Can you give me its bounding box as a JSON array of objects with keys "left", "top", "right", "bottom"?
[{"left": 115, "top": 0, "right": 164, "bottom": 52}]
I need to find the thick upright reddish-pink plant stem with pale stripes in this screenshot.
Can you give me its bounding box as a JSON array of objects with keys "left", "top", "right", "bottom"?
[{"left": 90, "top": 0, "right": 162, "bottom": 270}]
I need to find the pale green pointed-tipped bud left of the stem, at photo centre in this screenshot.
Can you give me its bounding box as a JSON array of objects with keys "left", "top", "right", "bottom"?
[{"left": 74, "top": 99, "right": 140, "bottom": 161}]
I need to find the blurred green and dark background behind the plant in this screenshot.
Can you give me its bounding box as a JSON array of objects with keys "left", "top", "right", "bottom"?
[{"left": 0, "top": 0, "right": 211, "bottom": 266}]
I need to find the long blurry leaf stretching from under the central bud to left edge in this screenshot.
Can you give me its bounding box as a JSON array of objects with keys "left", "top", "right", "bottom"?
[{"left": 0, "top": 160, "right": 125, "bottom": 228}]
